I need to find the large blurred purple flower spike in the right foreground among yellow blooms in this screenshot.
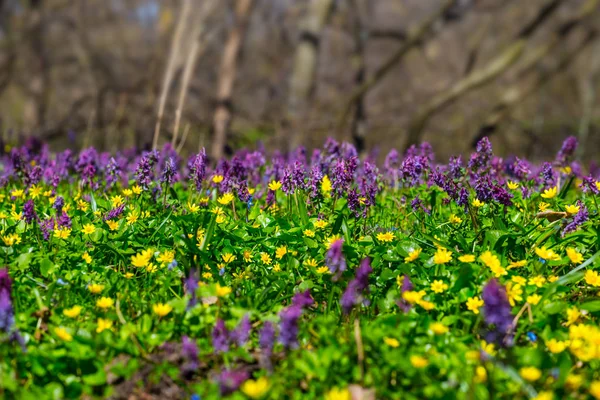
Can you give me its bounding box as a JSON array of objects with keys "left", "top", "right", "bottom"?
[{"left": 481, "top": 279, "right": 513, "bottom": 346}]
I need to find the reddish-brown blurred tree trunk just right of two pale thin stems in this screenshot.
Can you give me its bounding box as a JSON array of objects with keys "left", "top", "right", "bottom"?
[{"left": 211, "top": 0, "right": 254, "bottom": 161}]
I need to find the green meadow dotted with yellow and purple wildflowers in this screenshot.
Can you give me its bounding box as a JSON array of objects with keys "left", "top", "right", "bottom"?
[{"left": 0, "top": 137, "right": 600, "bottom": 400}]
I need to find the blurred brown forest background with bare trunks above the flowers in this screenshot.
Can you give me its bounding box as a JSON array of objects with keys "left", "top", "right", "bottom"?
[{"left": 0, "top": 0, "right": 600, "bottom": 159}]
